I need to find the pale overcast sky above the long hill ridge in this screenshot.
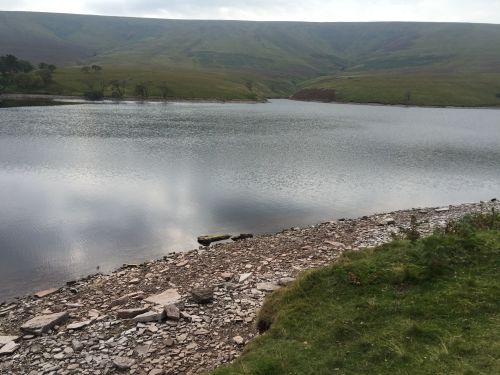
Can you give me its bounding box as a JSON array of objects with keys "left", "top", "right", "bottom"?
[{"left": 0, "top": 0, "right": 500, "bottom": 23}]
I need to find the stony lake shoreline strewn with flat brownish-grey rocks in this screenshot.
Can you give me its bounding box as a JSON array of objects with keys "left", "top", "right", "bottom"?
[{"left": 0, "top": 200, "right": 500, "bottom": 375}]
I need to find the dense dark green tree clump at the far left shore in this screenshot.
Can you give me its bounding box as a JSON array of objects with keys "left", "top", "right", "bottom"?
[{"left": 0, "top": 54, "right": 57, "bottom": 92}]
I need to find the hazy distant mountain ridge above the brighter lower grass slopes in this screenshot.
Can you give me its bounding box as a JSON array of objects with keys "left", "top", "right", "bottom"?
[{"left": 0, "top": 12, "right": 500, "bottom": 103}]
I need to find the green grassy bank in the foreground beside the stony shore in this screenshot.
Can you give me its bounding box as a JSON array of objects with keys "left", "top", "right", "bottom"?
[{"left": 213, "top": 214, "right": 500, "bottom": 375}]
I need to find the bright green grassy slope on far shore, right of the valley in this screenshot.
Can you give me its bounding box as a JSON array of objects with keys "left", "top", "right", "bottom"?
[{"left": 303, "top": 72, "right": 500, "bottom": 107}]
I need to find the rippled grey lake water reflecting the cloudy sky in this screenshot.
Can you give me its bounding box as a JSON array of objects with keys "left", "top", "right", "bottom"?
[{"left": 0, "top": 100, "right": 500, "bottom": 300}]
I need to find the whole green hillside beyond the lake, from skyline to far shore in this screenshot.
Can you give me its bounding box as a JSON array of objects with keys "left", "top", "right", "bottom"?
[{"left": 0, "top": 12, "right": 500, "bottom": 105}]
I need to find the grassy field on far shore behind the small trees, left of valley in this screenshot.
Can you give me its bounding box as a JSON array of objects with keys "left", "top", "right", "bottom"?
[{"left": 2, "top": 65, "right": 291, "bottom": 100}]
